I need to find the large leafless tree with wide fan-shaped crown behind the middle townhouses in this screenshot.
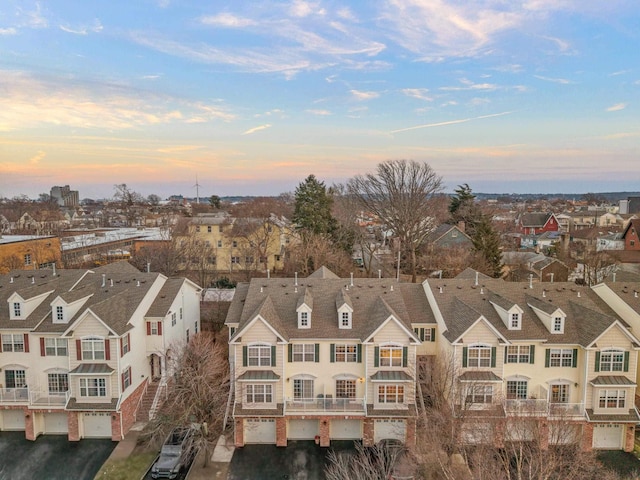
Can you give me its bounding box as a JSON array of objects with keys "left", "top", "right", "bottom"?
[{"left": 348, "top": 160, "right": 446, "bottom": 282}]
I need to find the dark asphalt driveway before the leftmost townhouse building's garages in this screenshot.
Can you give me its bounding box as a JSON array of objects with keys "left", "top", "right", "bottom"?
[{"left": 0, "top": 432, "right": 117, "bottom": 480}]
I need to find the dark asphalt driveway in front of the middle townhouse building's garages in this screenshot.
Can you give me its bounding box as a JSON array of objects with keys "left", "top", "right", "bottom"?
[{"left": 228, "top": 441, "right": 354, "bottom": 480}]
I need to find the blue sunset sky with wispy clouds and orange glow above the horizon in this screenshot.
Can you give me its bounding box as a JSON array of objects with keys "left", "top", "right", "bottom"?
[{"left": 0, "top": 0, "right": 640, "bottom": 198}]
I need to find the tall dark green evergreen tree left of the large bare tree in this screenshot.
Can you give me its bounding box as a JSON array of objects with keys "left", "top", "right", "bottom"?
[{"left": 293, "top": 175, "right": 338, "bottom": 235}]
